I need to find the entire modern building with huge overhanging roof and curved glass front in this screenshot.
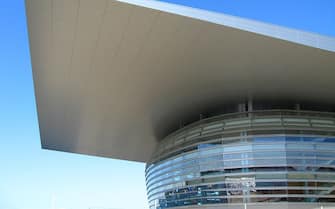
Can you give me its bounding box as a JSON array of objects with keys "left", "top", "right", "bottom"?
[{"left": 26, "top": 0, "right": 335, "bottom": 209}]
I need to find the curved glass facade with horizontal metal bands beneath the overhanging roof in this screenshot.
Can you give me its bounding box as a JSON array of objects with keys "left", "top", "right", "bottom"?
[{"left": 146, "top": 111, "right": 335, "bottom": 209}]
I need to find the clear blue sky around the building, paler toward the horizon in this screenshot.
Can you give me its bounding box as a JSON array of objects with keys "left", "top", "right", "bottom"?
[{"left": 0, "top": 0, "right": 335, "bottom": 209}]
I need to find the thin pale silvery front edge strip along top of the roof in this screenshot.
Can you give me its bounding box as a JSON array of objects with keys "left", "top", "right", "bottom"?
[{"left": 117, "top": 0, "right": 335, "bottom": 52}]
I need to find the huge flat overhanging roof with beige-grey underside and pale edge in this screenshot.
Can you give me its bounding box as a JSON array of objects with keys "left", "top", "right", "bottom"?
[{"left": 26, "top": 0, "right": 335, "bottom": 162}]
